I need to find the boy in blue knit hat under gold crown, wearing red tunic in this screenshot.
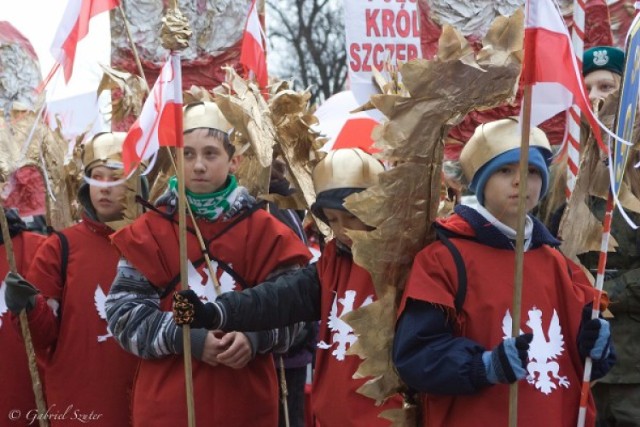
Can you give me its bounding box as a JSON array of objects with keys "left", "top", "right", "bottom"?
[{"left": 393, "top": 118, "right": 615, "bottom": 427}]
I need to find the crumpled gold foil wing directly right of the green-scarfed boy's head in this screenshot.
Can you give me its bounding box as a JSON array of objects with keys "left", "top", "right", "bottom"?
[{"left": 214, "top": 68, "right": 330, "bottom": 235}]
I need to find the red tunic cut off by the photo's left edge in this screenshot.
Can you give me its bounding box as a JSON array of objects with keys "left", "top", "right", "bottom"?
[{"left": 0, "top": 232, "right": 45, "bottom": 426}]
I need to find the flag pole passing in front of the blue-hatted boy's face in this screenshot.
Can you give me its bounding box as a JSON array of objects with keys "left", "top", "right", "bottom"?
[{"left": 509, "top": 85, "right": 531, "bottom": 427}]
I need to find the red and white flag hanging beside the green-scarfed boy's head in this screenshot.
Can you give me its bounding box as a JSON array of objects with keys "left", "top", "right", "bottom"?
[{"left": 122, "top": 55, "right": 182, "bottom": 175}]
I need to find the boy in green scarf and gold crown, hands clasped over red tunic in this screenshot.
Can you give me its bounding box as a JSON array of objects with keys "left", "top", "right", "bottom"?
[{"left": 107, "top": 102, "right": 311, "bottom": 427}]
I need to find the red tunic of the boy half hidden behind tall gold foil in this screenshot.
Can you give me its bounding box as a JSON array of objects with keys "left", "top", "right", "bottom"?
[{"left": 311, "top": 239, "right": 402, "bottom": 427}]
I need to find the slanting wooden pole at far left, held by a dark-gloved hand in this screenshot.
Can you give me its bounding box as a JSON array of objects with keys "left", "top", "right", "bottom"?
[{"left": 0, "top": 203, "right": 49, "bottom": 427}]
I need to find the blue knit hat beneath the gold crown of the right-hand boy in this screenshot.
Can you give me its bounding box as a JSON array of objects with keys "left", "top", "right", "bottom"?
[{"left": 469, "top": 147, "right": 549, "bottom": 206}]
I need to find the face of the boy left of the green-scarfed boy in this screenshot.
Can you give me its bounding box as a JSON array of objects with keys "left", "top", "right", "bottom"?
[{"left": 89, "top": 166, "right": 127, "bottom": 222}]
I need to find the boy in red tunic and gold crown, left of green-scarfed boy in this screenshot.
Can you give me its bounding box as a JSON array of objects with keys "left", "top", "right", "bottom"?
[{"left": 4, "top": 132, "right": 137, "bottom": 427}]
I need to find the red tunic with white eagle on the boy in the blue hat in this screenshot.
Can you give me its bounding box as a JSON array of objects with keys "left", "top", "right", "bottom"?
[{"left": 401, "top": 215, "right": 595, "bottom": 427}]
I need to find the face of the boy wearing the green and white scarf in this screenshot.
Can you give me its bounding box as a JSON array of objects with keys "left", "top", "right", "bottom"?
[{"left": 184, "top": 129, "right": 239, "bottom": 194}]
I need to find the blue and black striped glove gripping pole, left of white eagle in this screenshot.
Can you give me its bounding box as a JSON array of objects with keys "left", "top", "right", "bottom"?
[{"left": 482, "top": 334, "right": 533, "bottom": 384}]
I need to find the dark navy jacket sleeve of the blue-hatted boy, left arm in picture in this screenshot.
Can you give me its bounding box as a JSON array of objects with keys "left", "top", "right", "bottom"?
[{"left": 393, "top": 299, "right": 490, "bottom": 395}]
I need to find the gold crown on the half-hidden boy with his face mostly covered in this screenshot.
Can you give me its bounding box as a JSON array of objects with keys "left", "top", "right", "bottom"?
[{"left": 313, "top": 148, "right": 384, "bottom": 194}]
